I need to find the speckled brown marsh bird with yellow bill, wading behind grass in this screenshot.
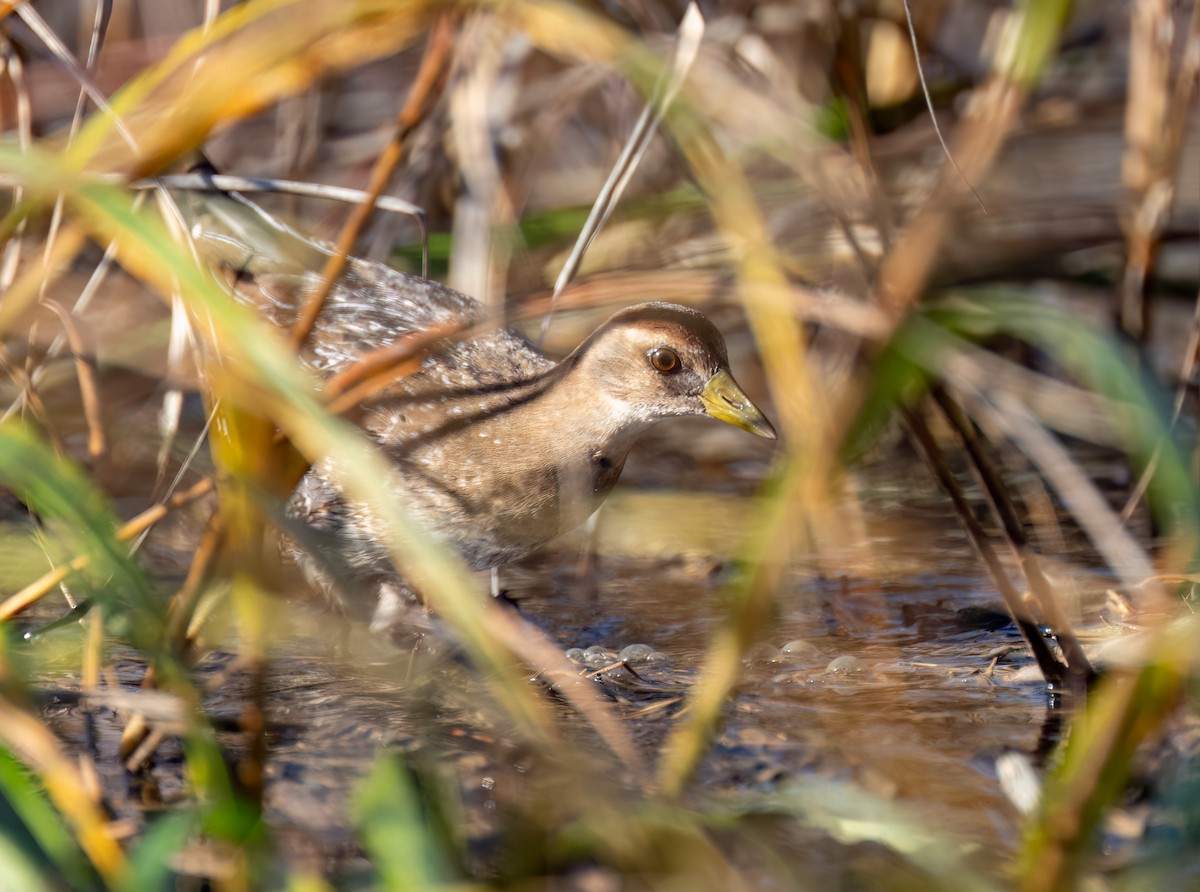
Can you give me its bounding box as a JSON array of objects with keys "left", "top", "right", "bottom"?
[{"left": 177, "top": 186, "right": 776, "bottom": 631}]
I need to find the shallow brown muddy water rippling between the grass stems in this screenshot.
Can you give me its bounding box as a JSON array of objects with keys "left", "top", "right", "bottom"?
[{"left": 23, "top": 446, "right": 1123, "bottom": 882}]
